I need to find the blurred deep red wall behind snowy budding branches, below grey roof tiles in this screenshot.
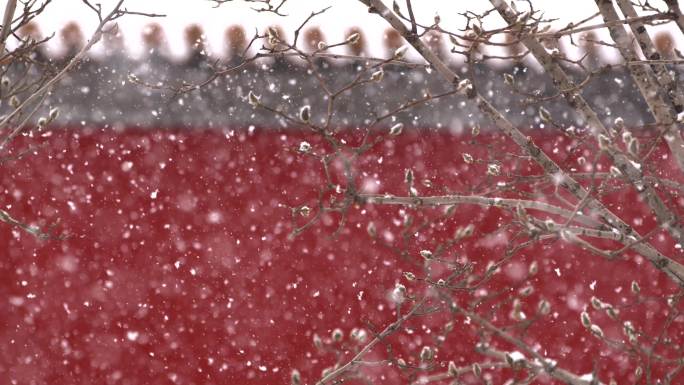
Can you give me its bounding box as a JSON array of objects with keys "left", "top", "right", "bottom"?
[{"left": 0, "top": 128, "right": 684, "bottom": 384}]
